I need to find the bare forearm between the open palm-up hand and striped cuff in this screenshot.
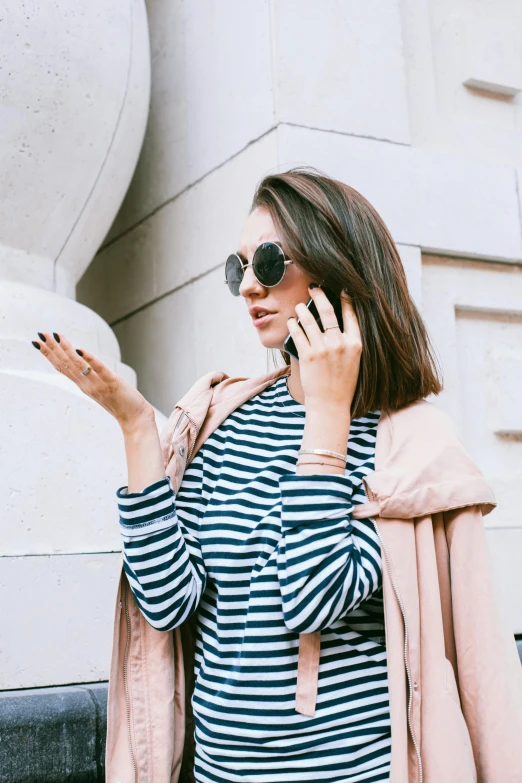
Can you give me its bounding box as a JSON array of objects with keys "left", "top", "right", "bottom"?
[{"left": 122, "top": 409, "right": 165, "bottom": 493}]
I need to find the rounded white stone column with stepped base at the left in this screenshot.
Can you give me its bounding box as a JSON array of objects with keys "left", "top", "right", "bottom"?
[{"left": 0, "top": 0, "right": 156, "bottom": 690}]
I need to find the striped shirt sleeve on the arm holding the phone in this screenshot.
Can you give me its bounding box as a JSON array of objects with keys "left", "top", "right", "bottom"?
[{"left": 277, "top": 475, "right": 382, "bottom": 633}]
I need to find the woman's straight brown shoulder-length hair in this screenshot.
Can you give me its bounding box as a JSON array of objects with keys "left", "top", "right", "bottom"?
[{"left": 252, "top": 167, "right": 442, "bottom": 418}]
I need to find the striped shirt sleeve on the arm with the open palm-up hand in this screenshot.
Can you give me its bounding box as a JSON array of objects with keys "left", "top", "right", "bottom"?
[{"left": 116, "top": 476, "right": 206, "bottom": 631}]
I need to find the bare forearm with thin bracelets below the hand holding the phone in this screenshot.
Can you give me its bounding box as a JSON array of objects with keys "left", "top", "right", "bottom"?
[{"left": 296, "top": 406, "right": 350, "bottom": 476}]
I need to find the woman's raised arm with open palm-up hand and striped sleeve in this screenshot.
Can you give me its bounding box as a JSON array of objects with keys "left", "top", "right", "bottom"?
[{"left": 31, "top": 332, "right": 206, "bottom": 630}]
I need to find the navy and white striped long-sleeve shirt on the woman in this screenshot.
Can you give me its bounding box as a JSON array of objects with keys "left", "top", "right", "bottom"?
[{"left": 117, "top": 377, "right": 391, "bottom": 783}]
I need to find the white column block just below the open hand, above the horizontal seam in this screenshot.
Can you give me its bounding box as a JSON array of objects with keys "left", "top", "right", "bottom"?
[{"left": 0, "top": 364, "right": 127, "bottom": 556}]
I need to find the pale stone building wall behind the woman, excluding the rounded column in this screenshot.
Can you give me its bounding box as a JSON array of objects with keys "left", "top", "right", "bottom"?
[{"left": 78, "top": 0, "right": 522, "bottom": 660}]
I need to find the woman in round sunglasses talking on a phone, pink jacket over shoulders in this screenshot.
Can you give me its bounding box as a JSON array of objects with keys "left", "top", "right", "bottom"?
[{"left": 34, "top": 169, "right": 522, "bottom": 783}]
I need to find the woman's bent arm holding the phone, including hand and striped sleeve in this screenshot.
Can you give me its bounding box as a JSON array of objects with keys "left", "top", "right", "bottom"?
[{"left": 277, "top": 287, "right": 382, "bottom": 633}]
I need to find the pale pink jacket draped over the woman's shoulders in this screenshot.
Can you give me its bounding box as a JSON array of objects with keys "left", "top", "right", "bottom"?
[{"left": 106, "top": 368, "right": 522, "bottom": 783}]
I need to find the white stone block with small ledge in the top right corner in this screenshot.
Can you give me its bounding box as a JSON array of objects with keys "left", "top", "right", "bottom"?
[{"left": 420, "top": 0, "right": 522, "bottom": 167}]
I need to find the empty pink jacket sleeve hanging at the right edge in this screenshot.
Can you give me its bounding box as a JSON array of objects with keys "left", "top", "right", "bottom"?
[{"left": 443, "top": 505, "right": 522, "bottom": 783}]
